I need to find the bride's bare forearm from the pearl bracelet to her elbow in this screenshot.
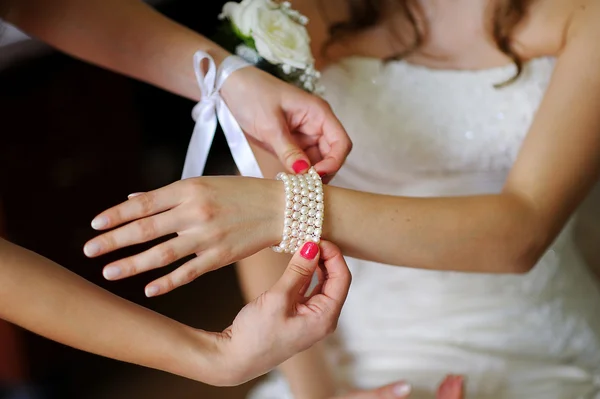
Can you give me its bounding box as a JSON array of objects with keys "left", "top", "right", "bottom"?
[{"left": 323, "top": 186, "right": 549, "bottom": 273}]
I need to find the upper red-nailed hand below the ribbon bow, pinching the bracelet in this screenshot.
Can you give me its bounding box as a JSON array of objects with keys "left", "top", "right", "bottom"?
[{"left": 221, "top": 68, "right": 352, "bottom": 182}]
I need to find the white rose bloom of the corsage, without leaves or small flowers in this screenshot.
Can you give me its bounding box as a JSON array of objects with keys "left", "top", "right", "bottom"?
[{"left": 221, "top": 0, "right": 314, "bottom": 69}]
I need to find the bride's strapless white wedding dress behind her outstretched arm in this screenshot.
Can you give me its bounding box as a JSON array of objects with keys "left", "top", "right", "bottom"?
[{"left": 250, "top": 58, "right": 600, "bottom": 399}]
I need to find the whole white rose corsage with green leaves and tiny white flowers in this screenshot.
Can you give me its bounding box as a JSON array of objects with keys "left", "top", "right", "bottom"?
[{"left": 217, "top": 0, "right": 323, "bottom": 94}]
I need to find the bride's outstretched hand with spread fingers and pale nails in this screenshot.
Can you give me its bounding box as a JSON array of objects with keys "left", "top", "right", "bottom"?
[{"left": 84, "top": 177, "right": 285, "bottom": 296}]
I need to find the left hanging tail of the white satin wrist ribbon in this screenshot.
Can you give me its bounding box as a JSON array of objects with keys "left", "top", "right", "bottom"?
[{"left": 182, "top": 109, "right": 217, "bottom": 179}]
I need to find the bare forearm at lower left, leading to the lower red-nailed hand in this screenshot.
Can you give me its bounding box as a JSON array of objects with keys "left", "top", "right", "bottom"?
[{"left": 0, "top": 239, "right": 219, "bottom": 381}]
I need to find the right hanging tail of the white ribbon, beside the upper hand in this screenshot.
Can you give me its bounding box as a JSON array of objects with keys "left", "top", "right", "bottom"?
[{"left": 217, "top": 101, "right": 263, "bottom": 178}]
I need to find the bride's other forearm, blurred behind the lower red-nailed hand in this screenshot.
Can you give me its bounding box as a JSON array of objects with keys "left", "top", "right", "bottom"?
[{"left": 237, "top": 250, "right": 335, "bottom": 399}]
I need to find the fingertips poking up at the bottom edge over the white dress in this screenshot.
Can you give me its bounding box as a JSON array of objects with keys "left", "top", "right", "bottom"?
[{"left": 333, "top": 375, "right": 464, "bottom": 399}]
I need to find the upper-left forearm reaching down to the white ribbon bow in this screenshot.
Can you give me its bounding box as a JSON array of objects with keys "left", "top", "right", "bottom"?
[{"left": 7, "top": 0, "right": 228, "bottom": 100}]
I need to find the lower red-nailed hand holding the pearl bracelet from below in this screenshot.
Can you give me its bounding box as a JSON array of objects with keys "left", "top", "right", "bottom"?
[{"left": 209, "top": 241, "right": 351, "bottom": 385}]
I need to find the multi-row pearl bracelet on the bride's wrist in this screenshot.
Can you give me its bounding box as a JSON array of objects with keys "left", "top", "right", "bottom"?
[{"left": 271, "top": 168, "right": 325, "bottom": 254}]
